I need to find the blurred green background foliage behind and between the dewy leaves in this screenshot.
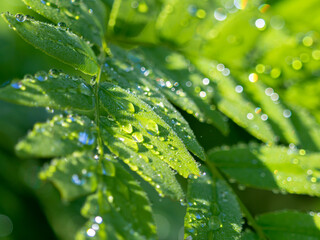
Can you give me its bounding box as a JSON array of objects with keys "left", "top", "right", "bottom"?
[{"left": 0, "top": 0, "right": 320, "bottom": 240}]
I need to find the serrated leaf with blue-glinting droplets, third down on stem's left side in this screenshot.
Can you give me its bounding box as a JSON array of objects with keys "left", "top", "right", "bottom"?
[{"left": 16, "top": 115, "right": 96, "bottom": 158}]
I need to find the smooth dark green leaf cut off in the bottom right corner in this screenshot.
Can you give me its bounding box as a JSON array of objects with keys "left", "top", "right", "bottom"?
[{"left": 257, "top": 211, "right": 320, "bottom": 240}]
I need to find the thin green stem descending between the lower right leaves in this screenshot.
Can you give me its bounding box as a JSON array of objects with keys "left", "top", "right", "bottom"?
[{"left": 206, "top": 158, "right": 268, "bottom": 240}]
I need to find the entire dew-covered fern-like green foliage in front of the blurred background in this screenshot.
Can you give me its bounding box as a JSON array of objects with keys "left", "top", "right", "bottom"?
[{"left": 0, "top": 0, "right": 320, "bottom": 240}]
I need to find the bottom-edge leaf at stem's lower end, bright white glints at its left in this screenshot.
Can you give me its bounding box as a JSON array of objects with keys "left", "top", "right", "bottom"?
[{"left": 76, "top": 159, "right": 157, "bottom": 240}]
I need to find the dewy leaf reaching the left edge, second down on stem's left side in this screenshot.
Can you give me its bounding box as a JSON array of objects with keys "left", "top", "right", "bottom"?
[{"left": 0, "top": 69, "right": 94, "bottom": 115}]
